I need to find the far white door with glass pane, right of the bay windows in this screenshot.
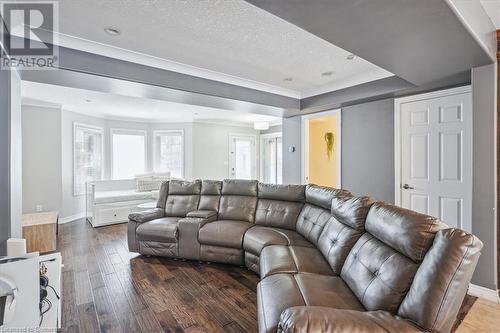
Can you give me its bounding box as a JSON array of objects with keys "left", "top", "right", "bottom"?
[{"left": 229, "top": 134, "right": 257, "bottom": 179}]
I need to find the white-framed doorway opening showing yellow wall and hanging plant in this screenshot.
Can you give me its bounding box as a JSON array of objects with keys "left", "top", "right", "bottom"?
[{"left": 302, "top": 110, "right": 342, "bottom": 188}]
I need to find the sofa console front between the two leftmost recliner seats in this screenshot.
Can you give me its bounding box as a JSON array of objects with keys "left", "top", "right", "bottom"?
[{"left": 177, "top": 214, "right": 217, "bottom": 260}]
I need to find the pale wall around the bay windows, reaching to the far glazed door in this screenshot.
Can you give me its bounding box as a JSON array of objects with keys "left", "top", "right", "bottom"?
[{"left": 22, "top": 105, "right": 259, "bottom": 218}]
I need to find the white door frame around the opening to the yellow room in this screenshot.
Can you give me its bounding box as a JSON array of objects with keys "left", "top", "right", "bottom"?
[{"left": 300, "top": 109, "right": 342, "bottom": 188}]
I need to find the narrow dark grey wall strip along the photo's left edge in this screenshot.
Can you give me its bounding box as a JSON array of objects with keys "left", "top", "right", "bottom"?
[{"left": 0, "top": 50, "right": 11, "bottom": 256}]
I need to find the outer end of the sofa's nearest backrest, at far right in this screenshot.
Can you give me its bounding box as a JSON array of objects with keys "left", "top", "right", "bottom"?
[{"left": 398, "top": 229, "right": 483, "bottom": 332}]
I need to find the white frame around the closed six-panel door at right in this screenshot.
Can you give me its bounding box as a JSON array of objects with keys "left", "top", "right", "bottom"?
[{"left": 394, "top": 85, "right": 473, "bottom": 206}]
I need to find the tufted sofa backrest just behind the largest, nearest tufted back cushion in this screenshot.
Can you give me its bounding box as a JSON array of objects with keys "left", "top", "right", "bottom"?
[{"left": 318, "top": 195, "right": 373, "bottom": 274}]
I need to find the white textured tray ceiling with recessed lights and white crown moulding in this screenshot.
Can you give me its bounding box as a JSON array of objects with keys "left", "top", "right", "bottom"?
[{"left": 48, "top": 0, "right": 392, "bottom": 97}]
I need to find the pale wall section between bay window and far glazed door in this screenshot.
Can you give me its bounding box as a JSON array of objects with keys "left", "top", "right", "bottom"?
[{"left": 192, "top": 123, "right": 260, "bottom": 179}]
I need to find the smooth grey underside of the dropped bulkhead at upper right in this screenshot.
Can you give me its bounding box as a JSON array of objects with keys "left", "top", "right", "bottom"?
[{"left": 247, "top": 0, "right": 493, "bottom": 85}]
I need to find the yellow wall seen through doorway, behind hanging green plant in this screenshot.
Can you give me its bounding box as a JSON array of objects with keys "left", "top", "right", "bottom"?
[{"left": 307, "top": 116, "right": 338, "bottom": 187}]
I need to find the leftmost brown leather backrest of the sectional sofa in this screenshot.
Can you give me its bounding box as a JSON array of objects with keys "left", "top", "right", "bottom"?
[{"left": 166, "top": 180, "right": 201, "bottom": 217}]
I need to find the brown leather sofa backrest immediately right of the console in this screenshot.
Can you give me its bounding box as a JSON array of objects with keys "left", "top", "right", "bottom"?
[{"left": 219, "top": 179, "right": 258, "bottom": 223}]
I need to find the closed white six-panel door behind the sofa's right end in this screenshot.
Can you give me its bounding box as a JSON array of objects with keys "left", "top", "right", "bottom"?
[{"left": 396, "top": 89, "right": 472, "bottom": 231}]
